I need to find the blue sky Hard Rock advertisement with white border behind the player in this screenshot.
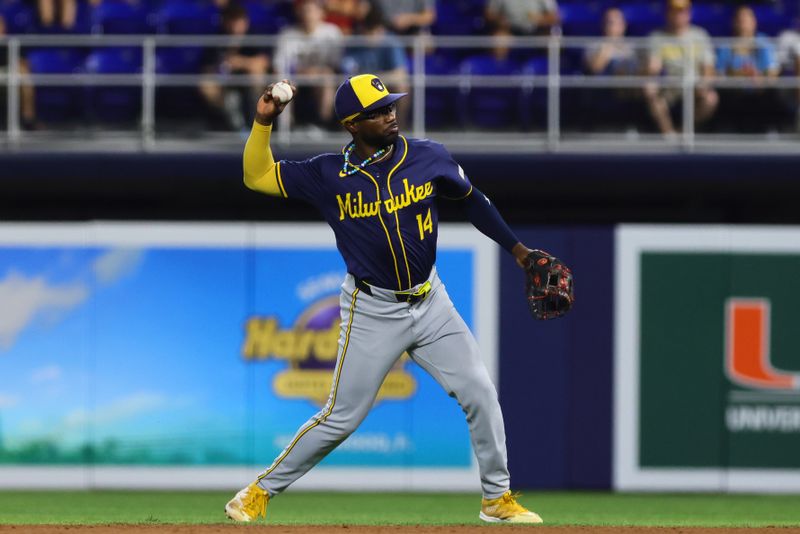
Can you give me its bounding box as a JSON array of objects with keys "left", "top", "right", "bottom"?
[{"left": 0, "top": 223, "right": 497, "bottom": 489}]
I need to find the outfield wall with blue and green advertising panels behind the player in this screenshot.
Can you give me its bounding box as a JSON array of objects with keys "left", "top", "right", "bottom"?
[{"left": 0, "top": 223, "right": 800, "bottom": 491}]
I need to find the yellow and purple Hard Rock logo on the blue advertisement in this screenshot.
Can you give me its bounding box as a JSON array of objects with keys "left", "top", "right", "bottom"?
[{"left": 242, "top": 295, "right": 416, "bottom": 406}]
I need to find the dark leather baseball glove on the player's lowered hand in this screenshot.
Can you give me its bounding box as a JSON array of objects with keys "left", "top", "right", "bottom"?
[{"left": 525, "top": 250, "right": 575, "bottom": 320}]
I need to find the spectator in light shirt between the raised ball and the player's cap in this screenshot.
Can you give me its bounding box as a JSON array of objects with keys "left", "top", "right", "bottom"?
[{"left": 274, "top": 0, "right": 343, "bottom": 126}]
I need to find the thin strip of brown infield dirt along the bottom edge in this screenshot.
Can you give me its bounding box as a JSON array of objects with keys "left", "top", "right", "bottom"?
[{"left": 0, "top": 525, "right": 800, "bottom": 534}]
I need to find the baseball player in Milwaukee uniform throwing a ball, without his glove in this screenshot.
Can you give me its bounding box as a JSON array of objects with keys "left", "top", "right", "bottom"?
[{"left": 225, "top": 74, "right": 542, "bottom": 523}]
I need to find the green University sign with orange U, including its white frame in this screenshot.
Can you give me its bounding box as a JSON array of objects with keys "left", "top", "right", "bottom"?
[{"left": 615, "top": 226, "right": 800, "bottom": 491}]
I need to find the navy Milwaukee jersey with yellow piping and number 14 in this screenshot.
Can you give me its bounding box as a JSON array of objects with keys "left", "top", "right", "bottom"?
[{"left": 277, "top": 136, "right": 472, "bottom": 290}]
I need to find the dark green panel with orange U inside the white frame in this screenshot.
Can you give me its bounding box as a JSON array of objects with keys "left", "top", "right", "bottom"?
[{"left": 639, "top": 253, "right": 800, "bottom": 468}]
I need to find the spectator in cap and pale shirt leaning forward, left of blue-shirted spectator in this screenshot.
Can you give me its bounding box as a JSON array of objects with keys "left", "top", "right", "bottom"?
[{"left": 644, "top": 0, "right": 719, "bottom": 136}]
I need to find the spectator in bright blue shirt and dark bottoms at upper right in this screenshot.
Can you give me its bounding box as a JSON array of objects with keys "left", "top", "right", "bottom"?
[{"left": 717, "top": 5, "right": 779, "bottom": 131}]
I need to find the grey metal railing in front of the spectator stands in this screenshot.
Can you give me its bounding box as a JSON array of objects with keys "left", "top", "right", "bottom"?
[{"left": 0, "top": 35, "right": 800, "bottom": 152}]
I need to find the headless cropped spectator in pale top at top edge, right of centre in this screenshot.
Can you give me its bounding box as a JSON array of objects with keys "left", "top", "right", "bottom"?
[{"left": 485, "top": 0, "right": 560, "bottom": 35}]
